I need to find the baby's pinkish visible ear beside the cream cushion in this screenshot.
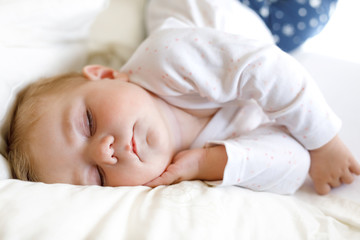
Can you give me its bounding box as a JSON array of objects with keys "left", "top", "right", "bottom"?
[{"left": 83, "top": 65, "right": 129, "bottom": 81}]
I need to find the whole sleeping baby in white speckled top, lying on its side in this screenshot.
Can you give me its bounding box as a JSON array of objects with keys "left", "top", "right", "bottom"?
[{"left": 4, "top": 0, "right": 360, "bottom": 194}]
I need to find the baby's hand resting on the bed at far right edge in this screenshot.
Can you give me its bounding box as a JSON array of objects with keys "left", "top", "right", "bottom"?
[{"left": 309, "top": 136, "right": 360, "bottom": 195}]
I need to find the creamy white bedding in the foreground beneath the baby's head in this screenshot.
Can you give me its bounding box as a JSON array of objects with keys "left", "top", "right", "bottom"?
[{"left": 0, "top": 178, "right": 360, "bottom": 240}]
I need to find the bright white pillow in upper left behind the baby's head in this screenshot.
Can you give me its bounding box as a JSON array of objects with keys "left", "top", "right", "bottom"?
[{"left": 0, "top": 0, "right": 109, "bottom": 178}]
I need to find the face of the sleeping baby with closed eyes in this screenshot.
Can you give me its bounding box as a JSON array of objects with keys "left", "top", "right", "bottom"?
[{"left": 31, "top": 70, "right": 174, "bottom": 186}]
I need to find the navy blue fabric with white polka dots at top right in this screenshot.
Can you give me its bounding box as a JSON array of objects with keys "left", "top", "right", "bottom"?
[{"left": 239, "top": 0, "right": 337, "bottom": 52}]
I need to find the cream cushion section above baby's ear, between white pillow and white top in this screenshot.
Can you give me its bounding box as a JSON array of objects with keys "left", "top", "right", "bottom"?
[{"left": 88, "top": 0, "right": 148, "bottom": 69}]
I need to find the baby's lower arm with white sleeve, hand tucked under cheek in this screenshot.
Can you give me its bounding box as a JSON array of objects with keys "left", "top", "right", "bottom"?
[{"left": 146, "top": 127, "right": 310, "bottom": 194}]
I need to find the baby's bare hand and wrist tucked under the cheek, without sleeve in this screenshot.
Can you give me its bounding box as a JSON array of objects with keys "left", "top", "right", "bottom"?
[{"left": 145, "top": 146, "right": 227, "bottom": 187}]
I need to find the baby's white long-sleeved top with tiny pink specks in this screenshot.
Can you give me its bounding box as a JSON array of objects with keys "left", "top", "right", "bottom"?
[{"left": 121, "top": 0, "right": 341, "bottom": 194}]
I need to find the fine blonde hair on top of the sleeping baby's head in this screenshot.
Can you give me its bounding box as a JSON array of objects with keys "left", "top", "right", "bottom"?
[{"left": 7, "top": 73, "right": 85, "bottom": 181}]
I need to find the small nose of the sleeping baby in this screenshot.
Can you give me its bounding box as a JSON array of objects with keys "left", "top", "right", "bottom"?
[{"left": 93, "top": 136, "right": 117, "bottom": 165}]
